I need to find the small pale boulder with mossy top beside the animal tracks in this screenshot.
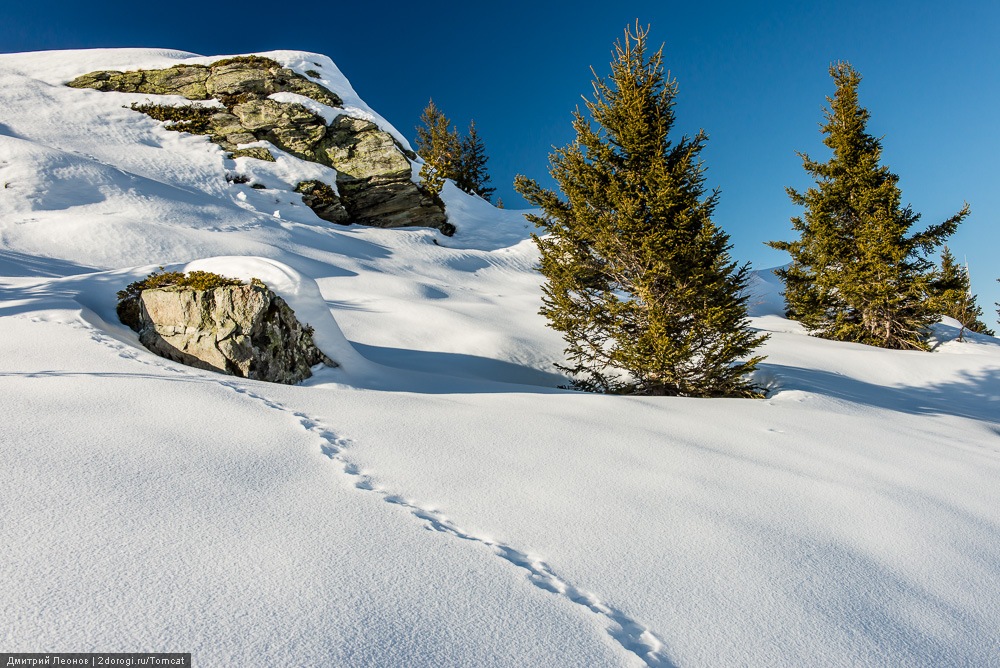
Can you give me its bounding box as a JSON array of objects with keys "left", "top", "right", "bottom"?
[{"left": 118, "top": 284, "right": 337, "bottom": 385}]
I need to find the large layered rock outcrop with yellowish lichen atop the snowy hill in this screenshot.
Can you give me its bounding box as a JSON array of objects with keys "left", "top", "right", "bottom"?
[{"left": 67, "top": 56, "right": 455, "bottom": 235}]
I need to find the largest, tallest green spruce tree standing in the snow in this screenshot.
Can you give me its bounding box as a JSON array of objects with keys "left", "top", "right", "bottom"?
[{"left": 515, "top": 24, "right": 766, "bottom": 397}]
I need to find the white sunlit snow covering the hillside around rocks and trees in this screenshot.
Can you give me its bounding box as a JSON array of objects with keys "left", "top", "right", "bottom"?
[{"left": 0, "top": 50, "right": 1000, "bottom": 667}]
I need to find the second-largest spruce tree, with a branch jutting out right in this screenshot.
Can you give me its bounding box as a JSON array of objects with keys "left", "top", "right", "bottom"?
[{"left": 769, "top": 63, "right": 969, "bottom": 349}]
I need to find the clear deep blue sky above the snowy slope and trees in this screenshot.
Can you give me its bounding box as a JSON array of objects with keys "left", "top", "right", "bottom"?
[{"left": 0, "top": 0, "right": 1000, "bottom": 316}]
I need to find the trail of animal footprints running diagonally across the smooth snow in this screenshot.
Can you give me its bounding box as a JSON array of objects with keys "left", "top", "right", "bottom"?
[{"left": 73, "top": 316, "right": 677, "bottom": 668}]
